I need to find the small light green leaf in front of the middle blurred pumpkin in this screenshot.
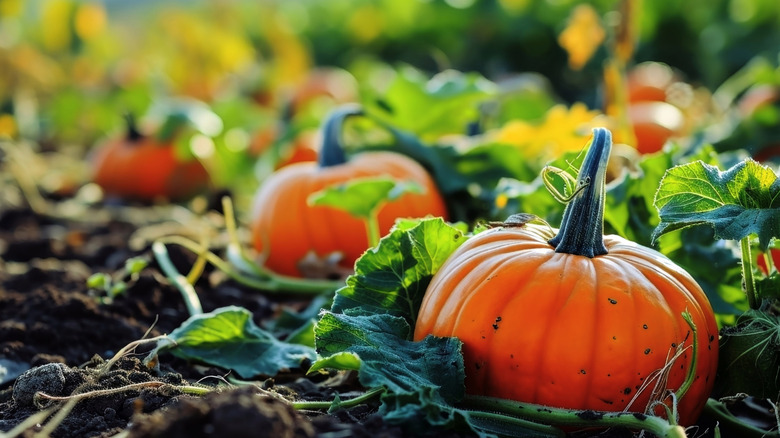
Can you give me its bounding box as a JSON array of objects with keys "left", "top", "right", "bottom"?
[{"left": 308, "top": 177, "right": 423, "bottom": 219}]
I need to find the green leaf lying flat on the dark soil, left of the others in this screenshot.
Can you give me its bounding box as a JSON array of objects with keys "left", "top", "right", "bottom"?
[{"left": 157, "top": 306, "right": 316, "bottom": 378}]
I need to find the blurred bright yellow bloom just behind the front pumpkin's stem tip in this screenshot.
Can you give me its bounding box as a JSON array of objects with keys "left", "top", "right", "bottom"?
[{"left": 494, "top": 102, "right": 607, "bottom": 161}]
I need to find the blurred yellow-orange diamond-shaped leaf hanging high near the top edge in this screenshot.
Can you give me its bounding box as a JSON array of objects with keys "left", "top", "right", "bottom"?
[{"left": 558, "top": 4, "right": 606, "bottom": 70}]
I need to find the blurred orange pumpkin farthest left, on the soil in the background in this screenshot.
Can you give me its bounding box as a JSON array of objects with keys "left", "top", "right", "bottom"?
[{"left": 92, "top": 116, "right": 209, "bottom": 201}]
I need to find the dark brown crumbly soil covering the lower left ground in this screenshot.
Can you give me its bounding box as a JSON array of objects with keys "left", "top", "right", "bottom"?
[{"left": 0, "top": 201, "right": 402, "bottom": 438}]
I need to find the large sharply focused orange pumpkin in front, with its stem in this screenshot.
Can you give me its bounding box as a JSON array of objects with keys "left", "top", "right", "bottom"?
[{"left": 414, "top": 128, "right": 718, "bottom": 425}]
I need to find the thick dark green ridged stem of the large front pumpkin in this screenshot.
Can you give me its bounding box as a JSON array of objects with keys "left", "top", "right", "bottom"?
[{"left": 549, "top": 128, "right": 612, "bottom": 258}]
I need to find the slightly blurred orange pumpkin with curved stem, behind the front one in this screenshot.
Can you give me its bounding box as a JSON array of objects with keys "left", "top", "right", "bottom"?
[{"left": 251, "top": 105, "right": 447, "bottom": 276}]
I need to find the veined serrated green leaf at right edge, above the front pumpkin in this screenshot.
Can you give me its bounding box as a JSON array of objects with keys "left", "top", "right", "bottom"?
[{"left": 653, "top": 159, "right": 780, "bottom": 250}]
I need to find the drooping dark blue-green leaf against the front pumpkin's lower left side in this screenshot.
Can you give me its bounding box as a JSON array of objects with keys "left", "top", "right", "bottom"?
[{"left": 311, "top": 309, "right": 549, "bottom": 437}]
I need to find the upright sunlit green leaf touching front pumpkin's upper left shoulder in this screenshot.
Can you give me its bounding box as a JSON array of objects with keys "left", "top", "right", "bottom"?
[{"left": 331, "top": 218, "right": 466, "bottom": 326}]
